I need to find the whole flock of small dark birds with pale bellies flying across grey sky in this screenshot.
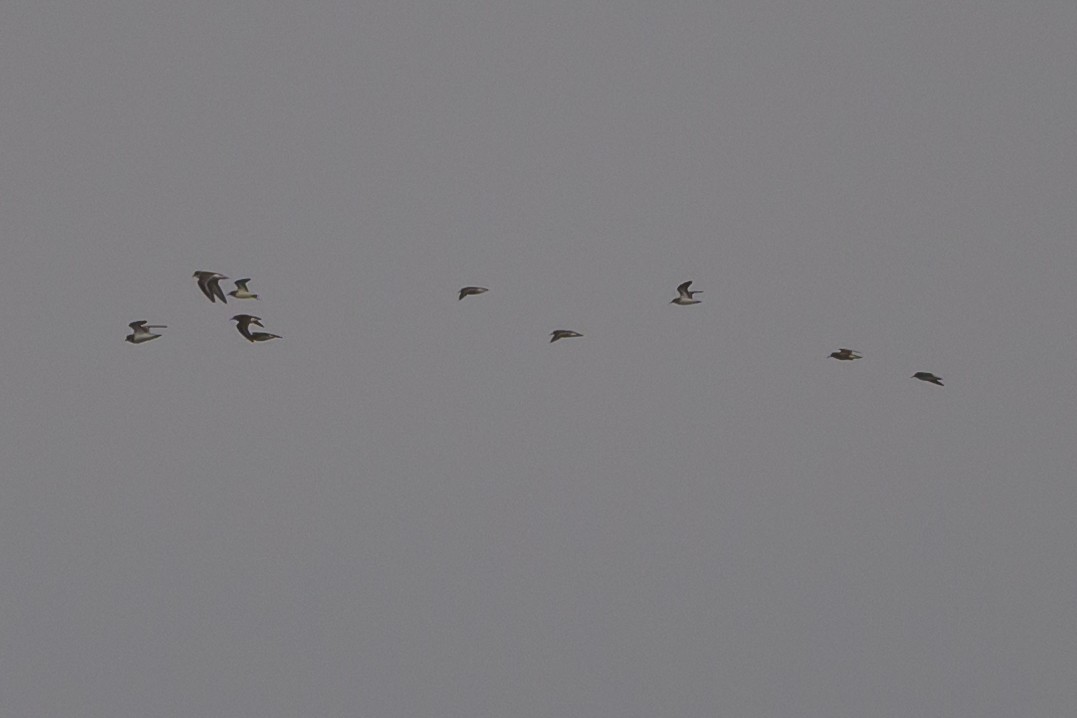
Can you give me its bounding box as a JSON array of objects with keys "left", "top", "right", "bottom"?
[{"left": 127, "top": 271, "right": 942, "bottom": 386}]
